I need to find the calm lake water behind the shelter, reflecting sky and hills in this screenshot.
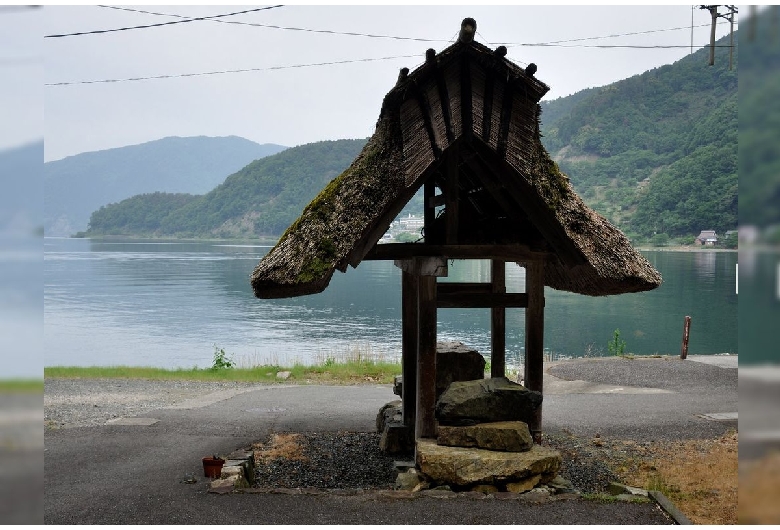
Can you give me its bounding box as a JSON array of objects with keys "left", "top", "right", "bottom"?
[{"left": 44, "top": 238, "right": 737, "bottom": 368}]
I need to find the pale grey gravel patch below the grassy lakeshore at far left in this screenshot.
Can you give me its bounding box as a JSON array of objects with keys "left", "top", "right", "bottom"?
[{"left": 43, "top": 378, "right": 258, "bottom": 428}]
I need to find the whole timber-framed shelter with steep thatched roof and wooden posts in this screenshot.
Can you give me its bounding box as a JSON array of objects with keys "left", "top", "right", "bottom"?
[{"left": 251, "top": 18, "right": 661, "bottom": 443}]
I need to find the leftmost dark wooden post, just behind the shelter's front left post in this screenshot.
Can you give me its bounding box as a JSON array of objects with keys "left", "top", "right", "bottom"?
[{"left": 401, "top": 271, "right": 419, "bottom": 430}]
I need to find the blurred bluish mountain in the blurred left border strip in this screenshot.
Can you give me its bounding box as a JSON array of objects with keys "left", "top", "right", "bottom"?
[{"left": 0, "top": 141, "right": 43, "bottom": 235}]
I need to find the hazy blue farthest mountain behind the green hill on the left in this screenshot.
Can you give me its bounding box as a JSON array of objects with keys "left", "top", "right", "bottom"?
[{"left": 43, "top": 136, "right": 286, "bottom": 236}]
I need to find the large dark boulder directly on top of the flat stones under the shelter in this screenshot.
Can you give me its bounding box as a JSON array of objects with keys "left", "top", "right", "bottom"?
[{"left": 436, "top": 377, "right": 542, "bottom": 425}]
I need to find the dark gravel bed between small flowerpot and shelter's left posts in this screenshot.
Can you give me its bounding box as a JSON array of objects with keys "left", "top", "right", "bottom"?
[{"left": 255, "top": 432, "right": 411, "bottom": 489}]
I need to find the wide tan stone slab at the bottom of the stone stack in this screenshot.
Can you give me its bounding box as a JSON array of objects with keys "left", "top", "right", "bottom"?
[{"left": 417, "top": 439, "right": 561, "bottom": 486}]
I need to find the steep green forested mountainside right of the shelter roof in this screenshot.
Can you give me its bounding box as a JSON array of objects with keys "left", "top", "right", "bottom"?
[{"left": 541, "top": 31, "right": 737, "bottom": 241}]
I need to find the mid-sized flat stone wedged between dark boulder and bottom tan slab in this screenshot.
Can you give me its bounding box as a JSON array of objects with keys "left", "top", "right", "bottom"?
[{"left": 436, "top": 421, "right": 534, "bottom": 453}]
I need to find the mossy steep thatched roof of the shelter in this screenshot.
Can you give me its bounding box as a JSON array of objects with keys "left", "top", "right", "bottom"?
[{"left": 251, "top": 19, "right": 661, "bottom": 298}]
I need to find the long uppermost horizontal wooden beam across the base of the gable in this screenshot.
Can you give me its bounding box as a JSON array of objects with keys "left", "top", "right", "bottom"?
[{"left": 363, "top": 243, "right": 547, "bottom": 262}]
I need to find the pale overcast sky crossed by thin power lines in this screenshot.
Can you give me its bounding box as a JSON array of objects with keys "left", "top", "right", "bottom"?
[{"left": 25, "top": 5, "right": 728, "bottom": 161}]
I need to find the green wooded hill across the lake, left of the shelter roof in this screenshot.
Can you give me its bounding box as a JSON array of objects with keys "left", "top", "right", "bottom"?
[{"left": 86, "top": 139, "right": 366, "bottom": 238}]
